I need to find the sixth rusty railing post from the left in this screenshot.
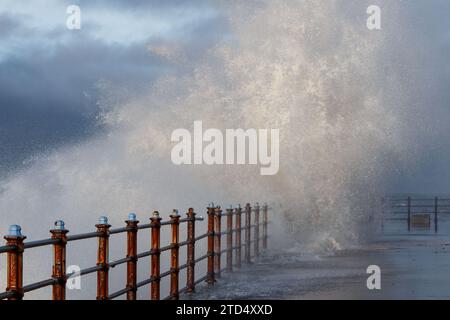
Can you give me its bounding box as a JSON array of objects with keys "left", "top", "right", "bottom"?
[{"left": 170, "top": 210, "right": 180, "bottom": 300}]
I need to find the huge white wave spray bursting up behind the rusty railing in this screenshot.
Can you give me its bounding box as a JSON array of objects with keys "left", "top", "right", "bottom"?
[{"left": 0, "top": 1, "right": 418, "bottom": 296}]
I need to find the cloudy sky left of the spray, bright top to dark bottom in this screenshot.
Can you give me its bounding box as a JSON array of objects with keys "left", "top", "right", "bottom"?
[{"left": 0, "top": 0, "right": 225, "bottom": 176}]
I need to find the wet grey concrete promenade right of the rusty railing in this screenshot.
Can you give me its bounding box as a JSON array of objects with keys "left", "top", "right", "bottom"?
[{"left": 188, "top": 235, "right": 450, "bottom": 300}]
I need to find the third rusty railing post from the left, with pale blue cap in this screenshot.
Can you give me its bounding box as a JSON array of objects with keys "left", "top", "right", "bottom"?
[{"left": 95, "top": 217, "right": 111, "bottom": 300}]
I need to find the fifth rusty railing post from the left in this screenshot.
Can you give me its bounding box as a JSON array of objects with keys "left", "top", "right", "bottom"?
[{"left": 150, "top": 211, "right": 161, "bottom": 300}]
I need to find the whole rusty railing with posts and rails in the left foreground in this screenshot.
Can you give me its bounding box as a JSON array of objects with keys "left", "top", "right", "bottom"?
[{"left": 0, "top": 204, "right": 269, "bottom": 300}]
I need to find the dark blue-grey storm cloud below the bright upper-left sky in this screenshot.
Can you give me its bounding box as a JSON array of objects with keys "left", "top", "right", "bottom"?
[{"left": 0, "top": 39, "right": 169, "bottom": 176}]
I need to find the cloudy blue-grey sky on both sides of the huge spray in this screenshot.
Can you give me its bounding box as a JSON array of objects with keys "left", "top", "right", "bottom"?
[{"left": 0, "top": 0, "right": 450, "bottom": 192}]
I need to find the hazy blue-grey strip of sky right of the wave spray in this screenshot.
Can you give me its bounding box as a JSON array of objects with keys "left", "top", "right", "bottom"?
[{"left": 386, "top": 0, "right": 450, "bottom": 194}]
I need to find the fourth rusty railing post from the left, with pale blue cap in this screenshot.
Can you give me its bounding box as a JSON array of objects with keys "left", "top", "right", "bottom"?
[{"left": 125, "top": 213, "right": 139, "bottom": 300}]
